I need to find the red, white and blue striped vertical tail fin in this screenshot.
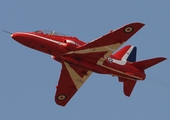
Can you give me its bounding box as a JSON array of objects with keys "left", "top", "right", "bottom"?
[{"left": 113, "top": 45, "right": 137, "bottom": 62}]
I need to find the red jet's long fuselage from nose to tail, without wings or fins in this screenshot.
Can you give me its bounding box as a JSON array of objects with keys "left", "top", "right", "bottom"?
[{"left": 11, "top": 31, "right": 145, "bottom": 80}]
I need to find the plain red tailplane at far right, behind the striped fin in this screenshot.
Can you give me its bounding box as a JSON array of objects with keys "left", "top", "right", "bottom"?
[{"left": 133, "top": 57, "right": 166, "bottom": 70}]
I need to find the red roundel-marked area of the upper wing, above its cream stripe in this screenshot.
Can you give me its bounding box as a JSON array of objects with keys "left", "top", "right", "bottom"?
[{"left": 78, "top": 22, "right": 144, "bottom": 50}]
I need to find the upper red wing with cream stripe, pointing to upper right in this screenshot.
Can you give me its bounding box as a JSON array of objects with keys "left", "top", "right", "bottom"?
[{"left": 65, "top": 23, "right": 144, "bottom": 64}]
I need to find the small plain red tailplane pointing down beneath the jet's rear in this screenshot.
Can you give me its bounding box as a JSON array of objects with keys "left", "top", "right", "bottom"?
[{"left": 119, "top": 77, "right": 137, "bottom": 97}]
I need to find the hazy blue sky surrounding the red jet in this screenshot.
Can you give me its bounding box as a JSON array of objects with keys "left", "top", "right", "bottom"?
[{"left": 0, "top": 0, "right": 170, "bottom": 120}]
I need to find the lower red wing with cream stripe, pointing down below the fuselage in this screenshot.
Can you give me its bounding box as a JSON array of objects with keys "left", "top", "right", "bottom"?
[{"left": 55, "top": 62, "right": 92, "bottom": 106}]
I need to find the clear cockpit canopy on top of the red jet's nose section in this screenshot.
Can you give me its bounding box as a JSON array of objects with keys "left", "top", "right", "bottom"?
[{"left": 35, "top": 30, "right": 68, "bottom": 36}]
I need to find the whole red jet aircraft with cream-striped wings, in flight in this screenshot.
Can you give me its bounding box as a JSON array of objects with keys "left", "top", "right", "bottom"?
[{"left": 11, "top": 23, "right": 166, "bottom": 106}]
